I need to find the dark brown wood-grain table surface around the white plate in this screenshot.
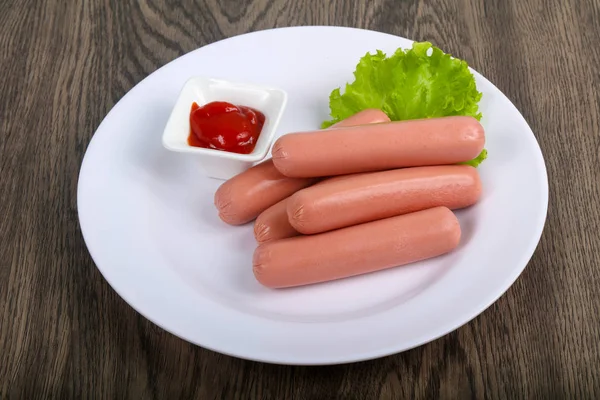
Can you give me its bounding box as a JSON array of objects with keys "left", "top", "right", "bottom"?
[{"left": 0, "top": 0, "right": 600, "bottom": 399}]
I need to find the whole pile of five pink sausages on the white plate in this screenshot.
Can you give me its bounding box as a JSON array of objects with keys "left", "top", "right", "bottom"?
[{"left": 215, "top": 110, "right": 485, "bottom": 288}]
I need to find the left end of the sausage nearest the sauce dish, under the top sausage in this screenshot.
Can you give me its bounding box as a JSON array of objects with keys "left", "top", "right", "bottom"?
[{"left": 214, "top": 159, "right": 314, "bottom": 225}]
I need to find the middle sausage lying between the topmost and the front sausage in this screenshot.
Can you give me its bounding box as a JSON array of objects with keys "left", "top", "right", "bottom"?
[{"left": 287, "top": 165, "right": 481, "bottom": 234}]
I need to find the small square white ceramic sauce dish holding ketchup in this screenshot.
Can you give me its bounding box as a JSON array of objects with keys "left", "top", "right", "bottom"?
[{"left": 162, "top": 77, "right": 287, "bottom": 180}]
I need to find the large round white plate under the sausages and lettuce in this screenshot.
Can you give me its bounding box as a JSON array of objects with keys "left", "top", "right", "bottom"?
[{"left": 77, "top": 27, "right": 548, "bottom": 364}]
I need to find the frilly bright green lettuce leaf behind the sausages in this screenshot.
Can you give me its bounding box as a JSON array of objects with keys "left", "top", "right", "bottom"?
[{"left": 322, "top": 42, "right": 487, "bottom": 167}]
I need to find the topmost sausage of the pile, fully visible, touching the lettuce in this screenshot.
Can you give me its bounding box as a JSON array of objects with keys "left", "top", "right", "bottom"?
[{"left": 272, "top": 116, "right": 485, "bottom": 178}]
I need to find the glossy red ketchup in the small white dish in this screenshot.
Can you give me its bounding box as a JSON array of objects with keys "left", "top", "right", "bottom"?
[{"left": 188, "top": 101, "right": 265, "bottom": 154}]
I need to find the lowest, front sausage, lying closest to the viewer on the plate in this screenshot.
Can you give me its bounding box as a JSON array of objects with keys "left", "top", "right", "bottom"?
[{"left": 253, "top": 207, "right": 461, "bottom": 288}]
